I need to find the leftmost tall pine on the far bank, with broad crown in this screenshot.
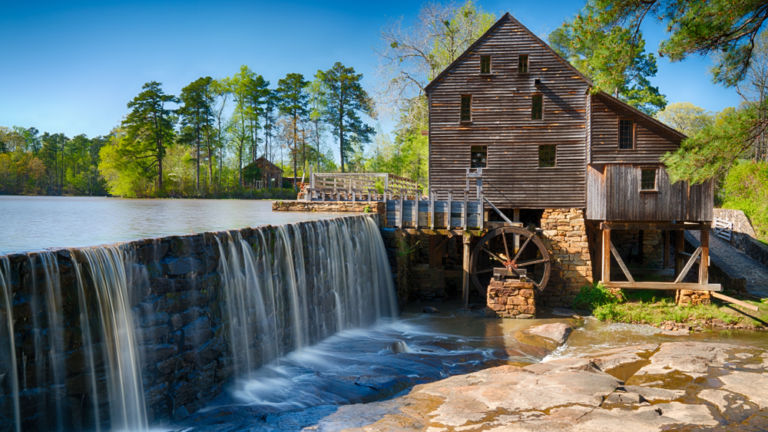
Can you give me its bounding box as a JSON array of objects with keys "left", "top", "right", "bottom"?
[{"left": 121, "top": 81, "right": 176, "bottom": 193}]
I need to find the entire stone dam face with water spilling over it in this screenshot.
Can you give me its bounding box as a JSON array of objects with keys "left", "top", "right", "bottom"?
[{"left": 0, "top": 216, "right": 396, "bottom": 430}]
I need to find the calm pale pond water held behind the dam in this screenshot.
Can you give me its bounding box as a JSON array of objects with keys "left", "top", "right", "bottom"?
[{"left": 0, "top": 196, "right": 334, "bottom": 255}]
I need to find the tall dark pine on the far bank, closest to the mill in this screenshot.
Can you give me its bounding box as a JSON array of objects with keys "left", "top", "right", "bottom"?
[{"left": 316, "top": 62, "right": 375, "bottom": 172}]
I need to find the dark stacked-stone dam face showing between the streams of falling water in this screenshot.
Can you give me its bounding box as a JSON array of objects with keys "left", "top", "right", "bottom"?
[{"left": 0, "top": 216, "right": 384, "bottom": 430}]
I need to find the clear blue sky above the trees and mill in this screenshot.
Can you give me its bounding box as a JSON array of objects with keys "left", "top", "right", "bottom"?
[{"left": 0, "top": 0, "right": 739, "bottom": 136}]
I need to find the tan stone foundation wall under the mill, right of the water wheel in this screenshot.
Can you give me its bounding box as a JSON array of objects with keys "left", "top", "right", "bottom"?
[{"left": 541, "top": 209, "right": 592, "bottom": 306}]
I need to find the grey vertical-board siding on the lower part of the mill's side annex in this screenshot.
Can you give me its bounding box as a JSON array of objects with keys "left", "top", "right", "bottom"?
[{"left": 587, "top": 164, "right": 713, "bottom": 222}]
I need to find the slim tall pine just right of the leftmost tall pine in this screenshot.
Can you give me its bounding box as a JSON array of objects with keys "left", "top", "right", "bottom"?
[{"left": 178, "top": 77, "right": 213, "bottom": 193}]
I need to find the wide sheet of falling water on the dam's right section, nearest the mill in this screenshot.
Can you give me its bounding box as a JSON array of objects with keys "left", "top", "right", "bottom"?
[{"left": 216, "top": 218, "right": 397, "bottom": 376}]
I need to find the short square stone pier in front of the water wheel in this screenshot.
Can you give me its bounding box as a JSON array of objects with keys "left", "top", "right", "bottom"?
[{"left": 487, "top": 279, "right": 536, "bottom": 318}]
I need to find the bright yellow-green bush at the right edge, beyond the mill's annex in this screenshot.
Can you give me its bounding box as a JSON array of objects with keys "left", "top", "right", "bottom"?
[{"left": 720, "top": 160, "right": 768, "bottom": 241}]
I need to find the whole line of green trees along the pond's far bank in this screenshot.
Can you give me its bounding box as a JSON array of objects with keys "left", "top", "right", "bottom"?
[{"left": 0, "top": 63, "right": 375, "bottom": 197}]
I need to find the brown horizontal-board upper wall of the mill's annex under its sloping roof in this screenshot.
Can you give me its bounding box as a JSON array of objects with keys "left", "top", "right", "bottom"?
[{"left": 590, "top": 94, "right": 682, "bottom": 164}]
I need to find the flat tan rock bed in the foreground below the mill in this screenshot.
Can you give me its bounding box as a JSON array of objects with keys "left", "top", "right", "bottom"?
[{"left": 311, "top": 324, "right": 768, "bottom": 432}]
